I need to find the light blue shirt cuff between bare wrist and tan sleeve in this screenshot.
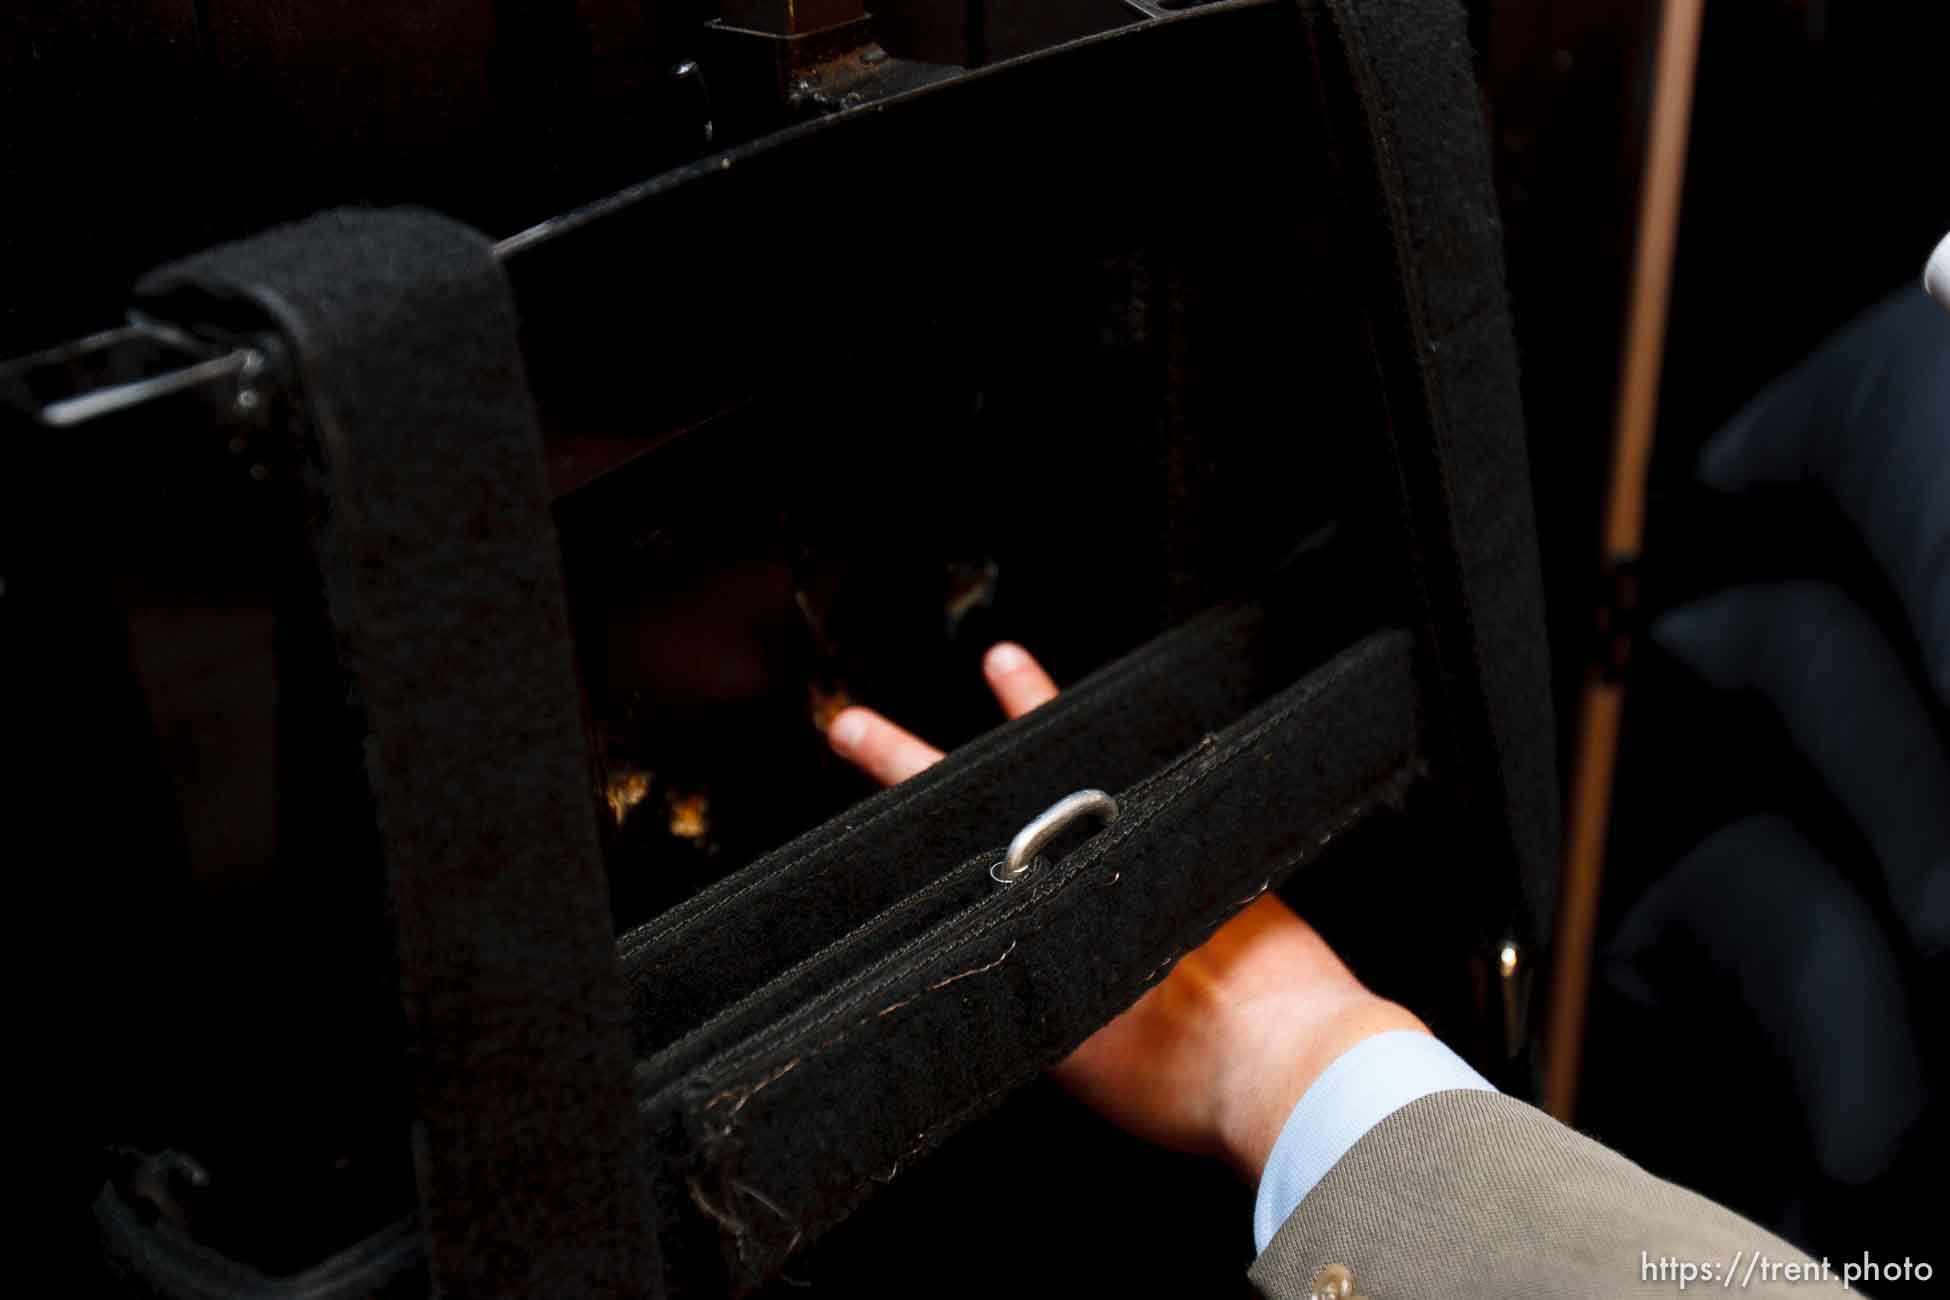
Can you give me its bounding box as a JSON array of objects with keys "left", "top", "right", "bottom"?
[{"left": 1252, "top": 1029, "right": 1496, "bottom": 1251}]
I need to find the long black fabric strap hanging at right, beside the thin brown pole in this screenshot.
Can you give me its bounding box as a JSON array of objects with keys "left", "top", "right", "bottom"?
[{"left": 1301, "top": 0, "right": 1558, "bottom": 982}]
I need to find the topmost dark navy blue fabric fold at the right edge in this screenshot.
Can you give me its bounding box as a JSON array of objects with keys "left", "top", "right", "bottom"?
[{"left": 1700, "top": 285, "right": 1950, "bottom": 704}]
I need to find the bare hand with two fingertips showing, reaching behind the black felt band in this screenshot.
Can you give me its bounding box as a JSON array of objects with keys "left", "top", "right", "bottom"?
[{"left": 827, "top": 641, "right": 1427, "bottom": 1183}]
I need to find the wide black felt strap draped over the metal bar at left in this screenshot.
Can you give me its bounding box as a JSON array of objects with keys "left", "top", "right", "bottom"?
[{"left": 138, "top": 210, "right": 655, "bottom": 1296}]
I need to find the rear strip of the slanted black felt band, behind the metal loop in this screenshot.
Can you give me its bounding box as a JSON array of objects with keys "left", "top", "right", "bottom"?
[{"left": 634, "top": 592, "right": 1326, "bottom": 1088}]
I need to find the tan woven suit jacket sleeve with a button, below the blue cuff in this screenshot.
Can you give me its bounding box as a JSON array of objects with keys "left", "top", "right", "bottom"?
[{"left": 1250, "top": 1091, "right": 1860, "bottom": 1300}]
